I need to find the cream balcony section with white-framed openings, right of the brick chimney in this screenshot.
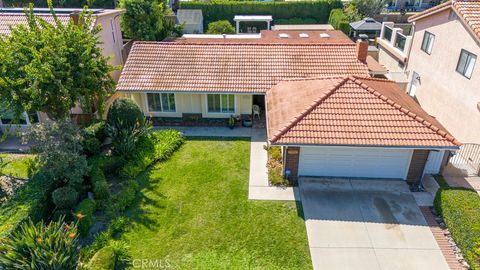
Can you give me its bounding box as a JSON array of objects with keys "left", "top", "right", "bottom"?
[{"left": 377, "top": 22, "right": 413, "bottom": 89}]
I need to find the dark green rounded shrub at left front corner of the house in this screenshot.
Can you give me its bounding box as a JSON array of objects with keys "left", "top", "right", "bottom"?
[{"left": 107, "top": 98, "right": 144, "bottom": 133}]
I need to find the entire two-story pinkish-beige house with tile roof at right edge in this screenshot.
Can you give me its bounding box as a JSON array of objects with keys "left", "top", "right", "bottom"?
[{"left": 407, "top": 0, "right": 480, "bottom": 144}]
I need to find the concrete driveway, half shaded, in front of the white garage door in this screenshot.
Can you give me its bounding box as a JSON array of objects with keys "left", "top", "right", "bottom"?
[{"left": 299, "top": 178, "right": 449, "bottom": 270}]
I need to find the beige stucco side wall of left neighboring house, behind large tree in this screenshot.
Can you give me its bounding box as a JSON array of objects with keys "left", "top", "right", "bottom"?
[{"left": 97, "top": 12, "right": 124, "bottom": 82}]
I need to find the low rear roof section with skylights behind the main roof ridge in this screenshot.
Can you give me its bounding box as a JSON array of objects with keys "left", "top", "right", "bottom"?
[{"left": 172, "top": 30, "right": 354, "bottom": 44}]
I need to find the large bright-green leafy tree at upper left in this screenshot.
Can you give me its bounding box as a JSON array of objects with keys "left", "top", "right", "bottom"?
[{"left": 0, "top": 5, "right": 114, "bottom": 119}]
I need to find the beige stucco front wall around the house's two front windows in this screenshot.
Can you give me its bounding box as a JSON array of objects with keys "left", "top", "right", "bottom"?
[{"left": 125, "top": 93, "right": 252, "bottom": 118}]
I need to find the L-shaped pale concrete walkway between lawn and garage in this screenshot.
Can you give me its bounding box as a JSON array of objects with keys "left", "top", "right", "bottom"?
[{"left": 248, "top": 129, "right": 300, "bottom": 201}]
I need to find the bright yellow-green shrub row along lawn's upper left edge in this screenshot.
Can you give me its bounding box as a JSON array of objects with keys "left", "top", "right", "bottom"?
[{"left": 120, "top": 130, "right": 185, "bottom": 178}]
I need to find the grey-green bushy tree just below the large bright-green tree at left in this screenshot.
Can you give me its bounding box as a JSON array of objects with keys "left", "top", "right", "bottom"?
[{"left": 24, "top": 120, "right": 88, "bottom": 190}]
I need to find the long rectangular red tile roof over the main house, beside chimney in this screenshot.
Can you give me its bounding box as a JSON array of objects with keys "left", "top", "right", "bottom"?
[{"left": 117, "top": 42, "right": 368, "bottom": 93}]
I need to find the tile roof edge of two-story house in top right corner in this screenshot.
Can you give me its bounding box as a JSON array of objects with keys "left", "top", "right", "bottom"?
[{"left": 408, "top": 0, "right": 480, "bottom": 40}]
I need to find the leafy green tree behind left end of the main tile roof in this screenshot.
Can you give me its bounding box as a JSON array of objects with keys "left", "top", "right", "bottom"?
[{"left": 120, "top": 0, "right": 176, "bottom": 41}]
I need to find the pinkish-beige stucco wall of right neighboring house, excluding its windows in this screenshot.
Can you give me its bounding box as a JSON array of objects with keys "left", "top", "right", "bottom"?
[{"left": 407, "top": 10, "right": 480, "bottom": 143}]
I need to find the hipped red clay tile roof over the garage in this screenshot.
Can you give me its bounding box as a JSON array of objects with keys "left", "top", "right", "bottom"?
[{"left": 266, "top": 76, "right": 460, "bottom": 148}]
